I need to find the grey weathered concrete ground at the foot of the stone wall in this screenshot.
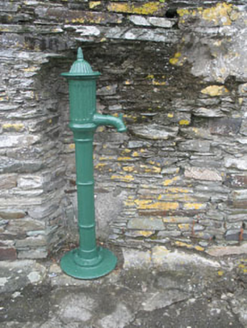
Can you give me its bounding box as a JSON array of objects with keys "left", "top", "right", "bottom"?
[{"left": 0, "top": 246, "right": 247, "bottom": 328}]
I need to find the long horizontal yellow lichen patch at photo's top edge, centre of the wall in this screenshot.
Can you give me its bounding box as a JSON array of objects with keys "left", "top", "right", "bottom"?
[{"left": 107, "top": 2, "right": 164, "bottom": 15}]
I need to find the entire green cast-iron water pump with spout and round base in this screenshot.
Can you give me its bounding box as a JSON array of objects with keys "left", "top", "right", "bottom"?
[{"left": 60, "top": 48, "right": 126, "bottom": 279}]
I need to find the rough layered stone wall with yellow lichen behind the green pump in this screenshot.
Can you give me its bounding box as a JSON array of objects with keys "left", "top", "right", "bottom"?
[{"left": 0, "top": 0, "right": 247, "bottom": 259}]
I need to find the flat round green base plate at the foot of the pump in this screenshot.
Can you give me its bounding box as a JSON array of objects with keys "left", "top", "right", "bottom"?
[{"left": 60, "top": 247, "right": 117, "bottom": 279}]
